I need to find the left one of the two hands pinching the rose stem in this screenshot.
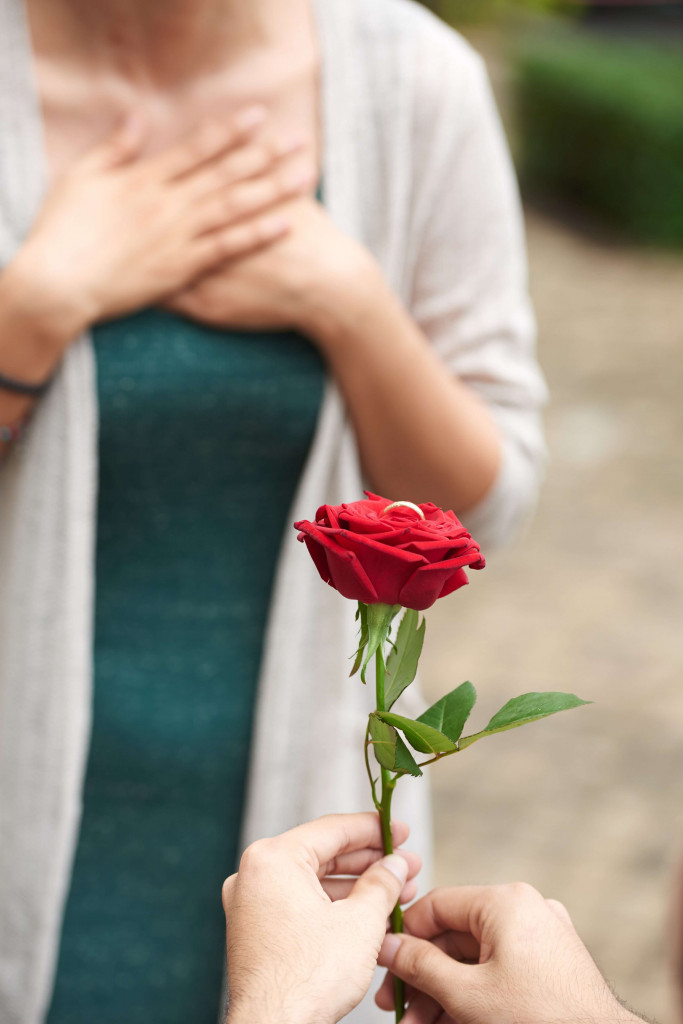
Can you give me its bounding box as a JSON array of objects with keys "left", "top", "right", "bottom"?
[{"left": 223, "top": 813, "right": 420, "bottom": 1024}]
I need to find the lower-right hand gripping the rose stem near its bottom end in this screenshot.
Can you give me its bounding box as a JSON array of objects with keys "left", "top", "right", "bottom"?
[{"left": 377, "top": 884, "right": 642, "bottom": 1024}]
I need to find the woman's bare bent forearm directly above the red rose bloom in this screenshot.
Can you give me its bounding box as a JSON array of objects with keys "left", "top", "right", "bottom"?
[{"left": 309, "top": 263, "right": 501, "bottom": 513}]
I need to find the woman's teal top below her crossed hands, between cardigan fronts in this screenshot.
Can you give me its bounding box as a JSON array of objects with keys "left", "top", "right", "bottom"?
[{"left": 48, "top": 309, "right": 324, "bottom": 1024}]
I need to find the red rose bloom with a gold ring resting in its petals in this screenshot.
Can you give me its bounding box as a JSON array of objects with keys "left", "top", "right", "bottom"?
[{"left": 294, "top": 490, "right": 485, "bottom": 611}]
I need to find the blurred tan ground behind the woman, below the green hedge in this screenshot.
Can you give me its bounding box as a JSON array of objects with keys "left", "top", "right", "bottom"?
[{"left": 423, "top": 203, "right": 683, "bottom": 1021}]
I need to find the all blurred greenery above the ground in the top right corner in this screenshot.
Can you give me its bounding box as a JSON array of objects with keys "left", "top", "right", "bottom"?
[{"left": 419, "top": 0, "right": 683, "bottom": 247}]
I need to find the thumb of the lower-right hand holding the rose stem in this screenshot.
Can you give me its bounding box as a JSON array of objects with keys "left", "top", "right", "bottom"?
[{"left": 378, "top": 934, "right": 471, "bottom": 1006}]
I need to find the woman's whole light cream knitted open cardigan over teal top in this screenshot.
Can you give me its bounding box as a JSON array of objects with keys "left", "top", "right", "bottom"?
[{"left": 0, "top": 0, "right": 545, "bottom": 1024}]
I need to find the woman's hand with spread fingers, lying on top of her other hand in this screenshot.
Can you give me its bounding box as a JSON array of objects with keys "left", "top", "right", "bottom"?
[{"left": 6, "top": 108, "right": 314, "bottom": 341}]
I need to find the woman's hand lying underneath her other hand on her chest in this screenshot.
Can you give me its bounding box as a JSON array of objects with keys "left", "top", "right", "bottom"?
[{"left": 167, "top": 197, "right": 379, "bottom": 342}]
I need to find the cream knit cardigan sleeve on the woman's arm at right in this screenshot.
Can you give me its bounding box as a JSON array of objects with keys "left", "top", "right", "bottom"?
[{"left": 411, "top": 11, "right": 546, "bottom": 550}]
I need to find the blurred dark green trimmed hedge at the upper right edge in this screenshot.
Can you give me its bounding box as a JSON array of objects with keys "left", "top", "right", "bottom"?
[{"left": 516, "top": 30, "right": 683, "bottom": 245}]
